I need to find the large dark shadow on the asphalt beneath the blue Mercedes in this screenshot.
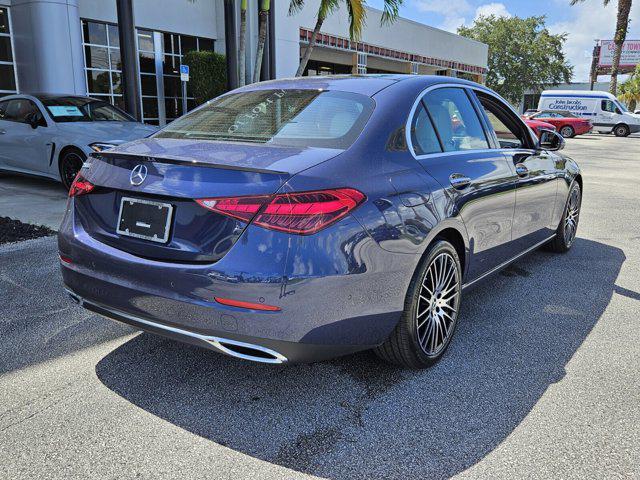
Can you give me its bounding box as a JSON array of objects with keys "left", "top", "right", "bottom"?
[{"left": 96, "top": 239, "right": 625, "bottom": 479}]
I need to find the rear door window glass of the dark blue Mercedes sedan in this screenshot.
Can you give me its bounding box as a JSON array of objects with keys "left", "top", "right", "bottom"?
[{"left": 423, "top": 88, "right": 489, "bottom": 152}]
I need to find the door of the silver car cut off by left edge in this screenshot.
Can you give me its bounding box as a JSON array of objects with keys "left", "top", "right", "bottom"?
[{"left": 0, "top": 98, "right": 51, "bottom": 173}]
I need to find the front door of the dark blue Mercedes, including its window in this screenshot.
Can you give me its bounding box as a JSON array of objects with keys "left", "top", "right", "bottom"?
[{"left": 475, "top": 91, "right": 560, "bottom": 252}]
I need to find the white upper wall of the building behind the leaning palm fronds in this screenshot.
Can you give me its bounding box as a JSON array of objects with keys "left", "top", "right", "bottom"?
[{"left": 275, "top": 0, "right": 488, "bottom": 77}]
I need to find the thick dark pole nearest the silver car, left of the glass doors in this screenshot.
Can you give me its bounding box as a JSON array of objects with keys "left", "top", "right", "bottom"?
[{"left": 116, "top": 0, "right": 142, "bottom": 121}]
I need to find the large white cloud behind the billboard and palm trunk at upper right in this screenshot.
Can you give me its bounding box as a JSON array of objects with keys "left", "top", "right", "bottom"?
[{"left": 549, "top": 0, "right": 640, "bottom": 82}]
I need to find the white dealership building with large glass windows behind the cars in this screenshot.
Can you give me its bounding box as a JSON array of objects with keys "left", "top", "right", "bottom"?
[{"left": 0, "top": 0, "right": 488, "bottom": 125}]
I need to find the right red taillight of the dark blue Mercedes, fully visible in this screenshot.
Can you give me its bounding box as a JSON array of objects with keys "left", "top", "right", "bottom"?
[{"left": 196, "top": 188, "right": 366, "bottom": 235}]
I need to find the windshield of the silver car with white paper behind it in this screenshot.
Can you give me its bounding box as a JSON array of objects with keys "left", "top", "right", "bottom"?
[{"left": 40, "top": 97, "right": 135, "bottom": 122}]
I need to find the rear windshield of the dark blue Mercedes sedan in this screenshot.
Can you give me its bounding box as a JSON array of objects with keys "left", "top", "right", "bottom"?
[{"left": 154, "top": 89, "right": 374, "bottom": 149}]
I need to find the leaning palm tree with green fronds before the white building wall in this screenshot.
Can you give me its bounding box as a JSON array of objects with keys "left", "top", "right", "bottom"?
[{"left": 289, "top": 0, "right": 404, "bottom": 77}]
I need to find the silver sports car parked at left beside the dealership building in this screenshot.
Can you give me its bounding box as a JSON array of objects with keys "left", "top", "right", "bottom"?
[{"left": 0, "top": 94, "right": 157, "bottom": 189}]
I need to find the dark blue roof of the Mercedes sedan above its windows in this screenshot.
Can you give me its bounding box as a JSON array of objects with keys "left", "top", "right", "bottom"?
[{"left": 233, "top": 74, "right": 484, "bottom": 97}]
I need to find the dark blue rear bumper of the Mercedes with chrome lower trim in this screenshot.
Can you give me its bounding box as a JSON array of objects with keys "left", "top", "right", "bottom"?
[{"left": 58, "top": 202, "right": 416, "bottom": 363}]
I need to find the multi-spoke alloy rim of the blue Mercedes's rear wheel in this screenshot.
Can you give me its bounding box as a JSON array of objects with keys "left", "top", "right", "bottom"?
[{"left": 416, "top": 252, "right": 460, "bottom": 356}]
